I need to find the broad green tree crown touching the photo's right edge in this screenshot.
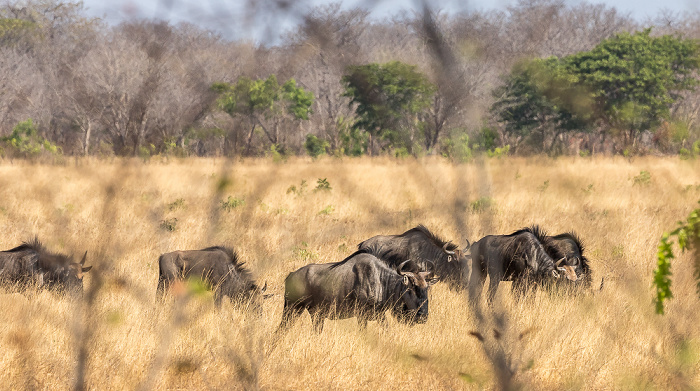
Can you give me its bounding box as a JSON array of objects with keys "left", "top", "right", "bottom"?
[{"left": 564, "top": 29, "right": 700, "bottom": 143}]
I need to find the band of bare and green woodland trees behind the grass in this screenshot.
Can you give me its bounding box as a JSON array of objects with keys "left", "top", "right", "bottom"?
[{"left": 0, "top": 0, "right": 700, "bottom": 160}]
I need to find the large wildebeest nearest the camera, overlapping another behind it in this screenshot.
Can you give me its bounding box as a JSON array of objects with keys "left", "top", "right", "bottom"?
[{"left": 278, "top": 251, "right": 435, "bottom": 333}]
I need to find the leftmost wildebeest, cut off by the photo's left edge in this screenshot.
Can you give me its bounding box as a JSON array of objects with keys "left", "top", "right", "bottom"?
[{"left": 0, "top": 237, "right": 92, "bottom": 292}]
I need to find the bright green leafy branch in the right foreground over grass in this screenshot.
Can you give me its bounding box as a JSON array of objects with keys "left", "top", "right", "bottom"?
[{"left": 654, "top": 201, "right": 700, "bottom": 314}]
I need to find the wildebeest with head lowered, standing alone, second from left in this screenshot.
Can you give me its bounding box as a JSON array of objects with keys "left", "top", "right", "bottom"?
[{"left": 157, "top": 246, "right": 267, "bottom": 309}]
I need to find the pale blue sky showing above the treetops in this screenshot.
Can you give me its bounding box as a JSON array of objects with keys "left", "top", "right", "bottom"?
[{"left": 83, "top": 0, "right": 700, "bottom": 41}]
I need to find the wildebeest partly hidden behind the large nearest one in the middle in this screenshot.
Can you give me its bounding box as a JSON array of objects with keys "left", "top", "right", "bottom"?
[{"left": 357, "top": 225, "right": 469, "bottom": 290}]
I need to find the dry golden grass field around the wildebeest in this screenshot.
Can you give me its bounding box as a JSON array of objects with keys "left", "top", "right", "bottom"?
[{"left": 0, "top": 158, "right": 700, "bottom": 390}]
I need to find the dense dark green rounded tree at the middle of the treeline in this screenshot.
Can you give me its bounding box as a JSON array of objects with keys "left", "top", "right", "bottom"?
[{"left": 342, "top": 61, "right": 435, "bottom": 154}]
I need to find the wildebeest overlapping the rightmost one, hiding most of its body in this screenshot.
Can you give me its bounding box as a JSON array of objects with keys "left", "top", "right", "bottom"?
[{"left": 470, "top": 226, "right": 577, "bottom": 302}]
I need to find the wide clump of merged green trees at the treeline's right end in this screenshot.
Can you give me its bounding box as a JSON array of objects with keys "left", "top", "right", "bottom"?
[{"left": 491, "top": 29, "right": 700, "bottom": 152}]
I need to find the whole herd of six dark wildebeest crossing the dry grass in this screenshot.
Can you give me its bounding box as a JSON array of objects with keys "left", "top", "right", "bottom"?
[{"left": 0, "top": 225, "right": 591, "bottom": 332}]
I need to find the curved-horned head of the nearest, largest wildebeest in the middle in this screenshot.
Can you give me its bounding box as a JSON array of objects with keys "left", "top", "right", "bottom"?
[{"left": 392, "top": 260, "right": 437, "bottom": 324}]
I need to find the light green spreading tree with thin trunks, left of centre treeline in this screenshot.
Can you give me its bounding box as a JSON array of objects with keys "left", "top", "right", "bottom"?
[{"left": 212, "top": 75, "right": 314, "bottom": 153}]
